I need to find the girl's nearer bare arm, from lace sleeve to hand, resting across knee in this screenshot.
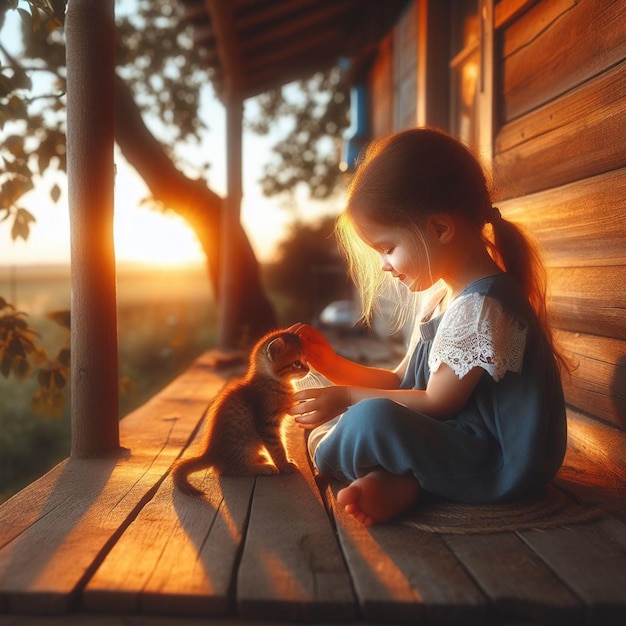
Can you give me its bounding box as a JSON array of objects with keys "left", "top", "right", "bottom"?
[{"left": 290, "top": 363, "right": 484, "bottom": 429}]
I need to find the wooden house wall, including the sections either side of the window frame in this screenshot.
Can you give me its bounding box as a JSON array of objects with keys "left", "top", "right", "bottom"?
[{"left": 369, "top": 0, "right": 626, "bottom": 444}]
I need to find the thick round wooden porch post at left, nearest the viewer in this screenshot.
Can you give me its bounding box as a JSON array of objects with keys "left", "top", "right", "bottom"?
[{"left": 65, "top": 0, "right": 120, "bottom": 458}]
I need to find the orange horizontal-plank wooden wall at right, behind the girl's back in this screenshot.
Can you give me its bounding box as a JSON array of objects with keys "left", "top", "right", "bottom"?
[{"left": 493, "top": 0, "right": 626, "bottom": 430}]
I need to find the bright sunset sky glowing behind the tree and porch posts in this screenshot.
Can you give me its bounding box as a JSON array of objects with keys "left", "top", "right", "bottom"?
[{"left": 0, "top": 4, "right": 333, "bottom": 266}]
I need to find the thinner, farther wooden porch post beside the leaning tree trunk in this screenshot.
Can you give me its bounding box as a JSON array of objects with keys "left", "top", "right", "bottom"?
[{"left": 218, "top": 90, "right": 243, "bottom": 350}]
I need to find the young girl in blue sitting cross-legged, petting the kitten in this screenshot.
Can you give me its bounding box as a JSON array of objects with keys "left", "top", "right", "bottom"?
[{"left": 291, "top": 128, "right": 566, "bottom": 525}]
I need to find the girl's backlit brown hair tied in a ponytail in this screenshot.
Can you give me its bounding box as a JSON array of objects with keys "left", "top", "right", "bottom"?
[{"left": 337, "top": 128, "right": 562, "bottom": 361}]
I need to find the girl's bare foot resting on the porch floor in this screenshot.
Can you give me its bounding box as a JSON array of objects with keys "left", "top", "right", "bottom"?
[{"left": 337, "top": 470, "right": 420, "bottom": 526}]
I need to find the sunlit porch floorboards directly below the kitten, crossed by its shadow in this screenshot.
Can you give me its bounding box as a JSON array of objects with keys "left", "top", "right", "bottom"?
[{"left": 83, "top": 475, "right": 254, "bottom": 616}]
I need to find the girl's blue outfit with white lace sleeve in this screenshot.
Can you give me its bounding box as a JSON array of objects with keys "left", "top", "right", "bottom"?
[{"left": 309, "top": 274, "right": 567, "bottom": 503}]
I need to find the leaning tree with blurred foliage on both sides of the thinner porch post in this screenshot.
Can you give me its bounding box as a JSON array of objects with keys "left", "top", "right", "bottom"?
[{"left": 0, "top": 0, "right": 348, "bottom": 412}]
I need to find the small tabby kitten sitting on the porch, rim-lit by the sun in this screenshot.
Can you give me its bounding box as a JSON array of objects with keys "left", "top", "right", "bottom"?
[{"left": 173, "top": 331, "right": 309, "bottom": 495}]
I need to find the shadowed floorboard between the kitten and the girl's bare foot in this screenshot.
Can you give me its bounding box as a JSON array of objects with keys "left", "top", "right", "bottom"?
[{"left": 236, "top": 424, "right": 356, "bottom": 621}]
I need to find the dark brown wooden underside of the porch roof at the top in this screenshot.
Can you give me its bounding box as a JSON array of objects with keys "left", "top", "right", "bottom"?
[{"left": 180, "top": 0, "right": 407, "bottom": 99}]
